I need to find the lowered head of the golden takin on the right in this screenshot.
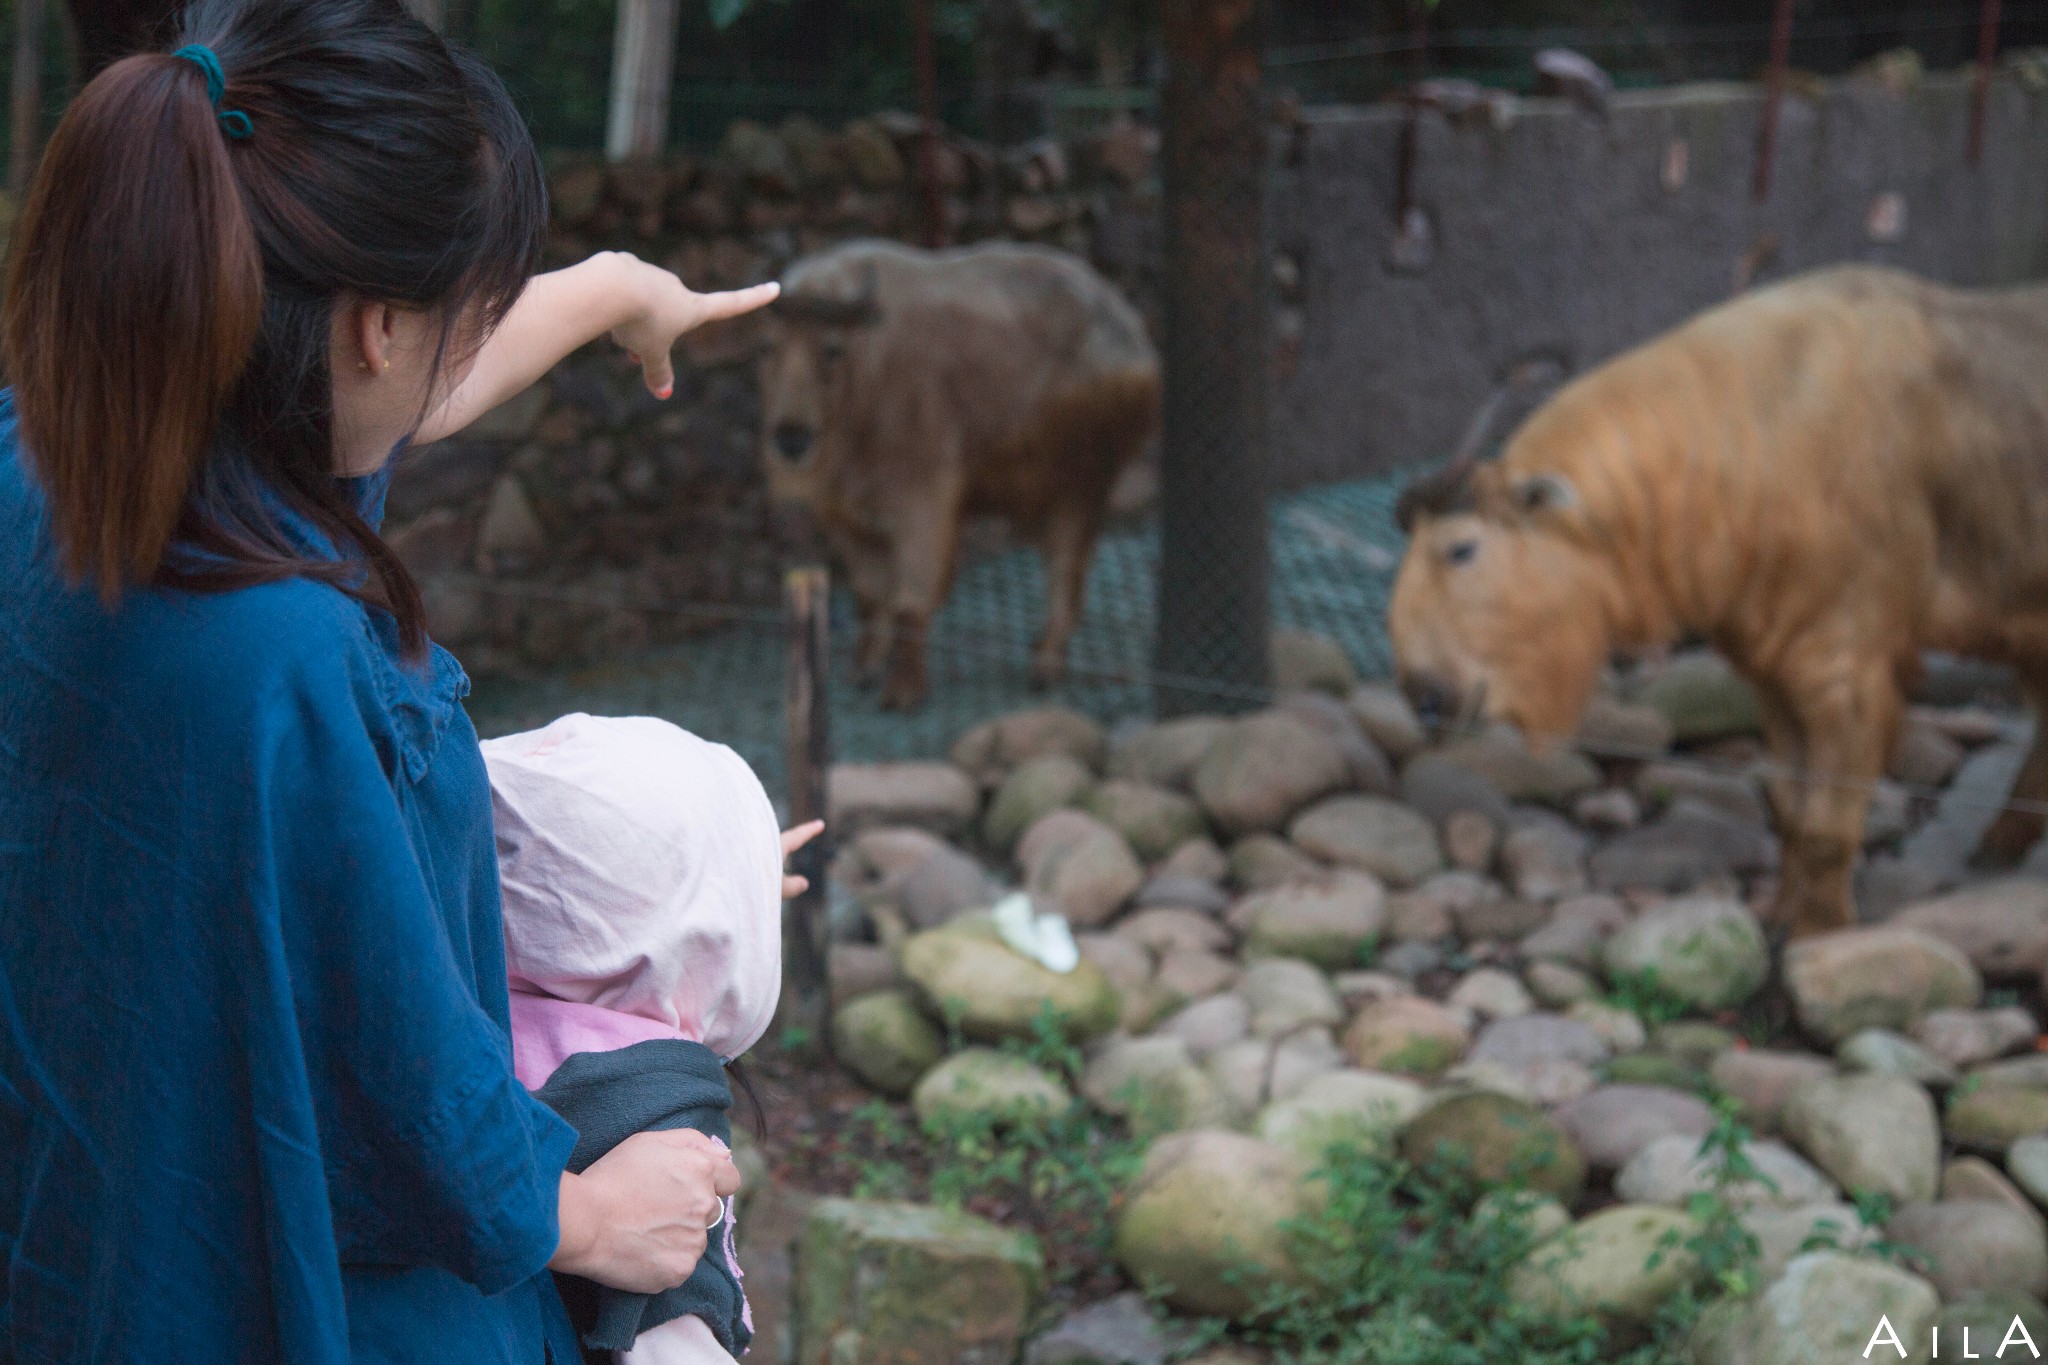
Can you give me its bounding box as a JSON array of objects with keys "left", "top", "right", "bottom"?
[{"left": 1389, "top": 442, "right": 1616, "bottom": 741}]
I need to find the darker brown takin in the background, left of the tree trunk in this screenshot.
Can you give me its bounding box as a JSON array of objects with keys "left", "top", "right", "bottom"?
[{"left": 760, "top": 241, "right": 1159, "bottom": 708}]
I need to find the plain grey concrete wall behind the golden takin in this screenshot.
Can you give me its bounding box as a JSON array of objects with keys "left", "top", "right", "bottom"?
[{"left": 1272, "top": 65, "right": 2048, "bottom": 485}]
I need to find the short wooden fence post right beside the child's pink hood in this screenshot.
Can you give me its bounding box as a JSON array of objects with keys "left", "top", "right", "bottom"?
[{"left": 778, "top": 567, "right": 831, "bottom": 1048}]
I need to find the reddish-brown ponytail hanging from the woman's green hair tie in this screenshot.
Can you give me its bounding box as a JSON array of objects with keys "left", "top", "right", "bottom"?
[{"left": 4, "top": 53, "right": 262, "bottom": 600}]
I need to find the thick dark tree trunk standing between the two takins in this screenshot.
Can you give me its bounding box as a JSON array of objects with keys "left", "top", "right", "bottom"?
[{"left": 1155, "top": 0, "right": 1272, "bottom": 716}]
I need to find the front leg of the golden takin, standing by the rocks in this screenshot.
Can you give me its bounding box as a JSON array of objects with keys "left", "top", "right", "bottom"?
[{"left": 1774, "top": 651, "right": 1903, "bottom": 937}]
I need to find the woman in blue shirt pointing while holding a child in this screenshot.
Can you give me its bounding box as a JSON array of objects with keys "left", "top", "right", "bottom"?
[{"left": 0, "top": 0, "right": 774, "bottom": 1365}]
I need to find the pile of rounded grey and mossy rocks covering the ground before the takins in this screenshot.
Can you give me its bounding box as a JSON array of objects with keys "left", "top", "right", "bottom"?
[{"left": 798, "top": 659, "right": 2048, "bottom": 1363}]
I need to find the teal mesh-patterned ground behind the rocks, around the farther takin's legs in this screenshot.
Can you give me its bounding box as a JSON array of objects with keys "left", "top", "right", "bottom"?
[{"left": 469, "top": 470, "right": 1401, "bottom": 794}]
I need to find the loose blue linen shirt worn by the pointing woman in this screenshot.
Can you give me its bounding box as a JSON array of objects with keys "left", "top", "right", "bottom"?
[{"left": 0, "top": 393, "right": 578, "bottom": 1365}]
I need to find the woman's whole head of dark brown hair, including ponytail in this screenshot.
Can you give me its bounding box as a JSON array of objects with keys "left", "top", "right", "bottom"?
[{"left": 4, "top": 0, "right": 547, "bottom": 657}]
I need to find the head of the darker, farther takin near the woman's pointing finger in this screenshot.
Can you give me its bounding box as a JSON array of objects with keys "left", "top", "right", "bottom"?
[{"left": 760, "top": 266, "right": 881, "bottom": 505}]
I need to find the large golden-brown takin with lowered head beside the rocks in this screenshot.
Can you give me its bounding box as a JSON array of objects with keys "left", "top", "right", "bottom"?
[{"left": 1391, "top": 268, "right": 2048, "bottom": 935}]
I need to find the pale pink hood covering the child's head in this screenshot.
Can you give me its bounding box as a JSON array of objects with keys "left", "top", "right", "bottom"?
[{"left": 483, "top": 714, "right": 782, "bottom": 1089}]
